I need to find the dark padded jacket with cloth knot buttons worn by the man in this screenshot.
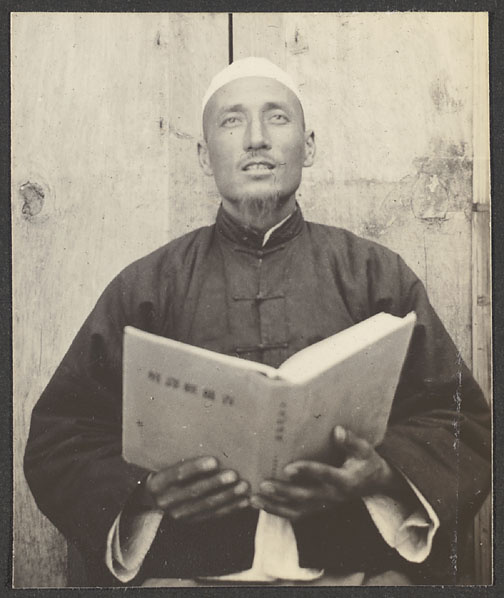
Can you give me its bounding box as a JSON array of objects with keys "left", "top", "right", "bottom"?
[{"left": 25, "top": 209, "right": 490, "bottom": 585}]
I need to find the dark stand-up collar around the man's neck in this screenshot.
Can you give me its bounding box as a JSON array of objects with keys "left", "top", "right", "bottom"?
[{"left": 216, "top": 203, "right": 304, "bottom": 249}]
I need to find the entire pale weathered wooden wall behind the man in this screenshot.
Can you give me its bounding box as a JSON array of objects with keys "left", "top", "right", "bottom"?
[{"left": 12, "top": 13, "right": 490, "bottom": 587}]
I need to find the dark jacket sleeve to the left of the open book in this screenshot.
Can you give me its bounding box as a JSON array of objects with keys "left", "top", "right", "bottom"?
[{"left": 24, "top": 275, "right": 154, "bottom": 560}]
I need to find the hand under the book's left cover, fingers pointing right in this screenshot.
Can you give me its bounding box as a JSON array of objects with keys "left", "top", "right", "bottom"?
[{"left": 137, "top": 457, "right": 249, "bottom": 522}]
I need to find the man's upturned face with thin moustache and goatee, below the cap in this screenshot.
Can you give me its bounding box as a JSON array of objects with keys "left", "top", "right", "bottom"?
[{"left": 199, "top": 77, "right": 314, "bottom": 225}]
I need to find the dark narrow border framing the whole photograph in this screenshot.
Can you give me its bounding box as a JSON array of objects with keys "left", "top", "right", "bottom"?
[{"left": 0, "top": 0, "right": 504, "bottom": 598}]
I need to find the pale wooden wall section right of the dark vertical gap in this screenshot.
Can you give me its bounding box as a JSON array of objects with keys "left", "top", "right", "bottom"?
[{"left": 233, "top": 13, "right": 492, "bottom": 583}]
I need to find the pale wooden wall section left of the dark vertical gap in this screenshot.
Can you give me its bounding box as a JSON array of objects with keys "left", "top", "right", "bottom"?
[{"left": 12, "top": 13, "right": 227, "bottom": 587}]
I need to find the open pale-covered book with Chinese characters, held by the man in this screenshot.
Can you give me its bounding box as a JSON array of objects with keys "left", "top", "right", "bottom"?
[{"left": 123, "top": 312, "right": 416, "bottom": 490}]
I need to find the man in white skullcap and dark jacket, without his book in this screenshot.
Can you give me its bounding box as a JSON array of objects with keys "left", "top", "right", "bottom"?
[{"left": 25, "top": 58, "right": 490, "bottom": 585}]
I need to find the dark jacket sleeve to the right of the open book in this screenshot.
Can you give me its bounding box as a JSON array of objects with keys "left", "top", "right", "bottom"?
[{"left": 377, "top": 253, "right": 491, "bottom": 533}]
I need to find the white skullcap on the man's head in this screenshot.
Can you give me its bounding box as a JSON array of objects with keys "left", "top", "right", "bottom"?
[{"left": 201, "top": 56, "right": 303, "bottom": 115}]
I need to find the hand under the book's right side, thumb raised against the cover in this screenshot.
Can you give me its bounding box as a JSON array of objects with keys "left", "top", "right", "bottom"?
[{"left": 251, "top": 426, "right": 405, "bottom": 521}]
